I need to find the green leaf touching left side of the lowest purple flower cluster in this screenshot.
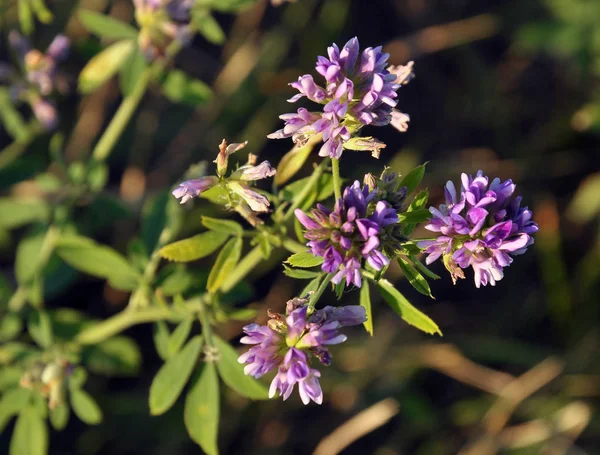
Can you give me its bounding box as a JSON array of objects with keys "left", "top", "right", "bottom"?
[{"left": 213, "top": 336, "right": 269, "bottom": 400}]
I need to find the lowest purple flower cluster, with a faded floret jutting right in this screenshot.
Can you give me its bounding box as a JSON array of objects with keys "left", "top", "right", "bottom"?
[{"left": 239, "top": 298, "right": 366, "bottom": 404}]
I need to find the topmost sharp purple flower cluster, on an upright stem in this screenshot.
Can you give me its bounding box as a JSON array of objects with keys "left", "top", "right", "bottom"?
[{"left": 268, "top": 38, "right": 412, "bottom": 158}]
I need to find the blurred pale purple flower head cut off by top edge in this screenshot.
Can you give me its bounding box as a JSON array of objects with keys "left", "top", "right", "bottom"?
[{"left": 133, "top": 0, "right": 193, "bottom": 60}]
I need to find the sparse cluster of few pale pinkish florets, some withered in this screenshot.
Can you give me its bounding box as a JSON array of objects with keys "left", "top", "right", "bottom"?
[{"left": 173, "top": 139, "right": 276, "bottom": 212}]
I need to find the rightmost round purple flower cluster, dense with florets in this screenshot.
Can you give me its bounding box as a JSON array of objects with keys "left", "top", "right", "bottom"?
[{"left": 418, "top": 171, "right": 539, "bottom": 287}]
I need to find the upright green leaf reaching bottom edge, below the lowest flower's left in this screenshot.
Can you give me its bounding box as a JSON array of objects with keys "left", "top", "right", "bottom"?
[{"left": 183, "top": 363, "right": 220, "bottom": 455}]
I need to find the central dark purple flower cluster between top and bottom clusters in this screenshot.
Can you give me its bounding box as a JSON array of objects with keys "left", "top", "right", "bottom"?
[{"left": 295, "top": 181, "right": 398, "bottom": 287}]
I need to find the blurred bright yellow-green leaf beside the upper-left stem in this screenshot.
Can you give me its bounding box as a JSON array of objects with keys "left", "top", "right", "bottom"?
[{"left": 79, "top": 40, "right": 136, "bottom": 94}]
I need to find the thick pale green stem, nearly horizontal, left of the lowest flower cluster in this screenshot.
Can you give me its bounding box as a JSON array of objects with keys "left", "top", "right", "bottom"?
[{"left": 75, "top": 296, "right": 203, "bottom": 344}]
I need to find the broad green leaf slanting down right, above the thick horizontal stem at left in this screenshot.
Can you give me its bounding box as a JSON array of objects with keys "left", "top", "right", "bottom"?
[{"left": 56, "top": 236, "right": 140, "bottom": 291}]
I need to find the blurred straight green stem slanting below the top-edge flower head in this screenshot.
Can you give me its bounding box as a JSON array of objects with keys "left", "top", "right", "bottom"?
[{"left": 93, "top": 68, "right": 153, "bottom": 161}]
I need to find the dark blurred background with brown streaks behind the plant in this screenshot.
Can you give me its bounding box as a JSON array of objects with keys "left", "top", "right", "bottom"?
[{"left": 0, "top": 0, "right": 600, "bottom": 455}]
